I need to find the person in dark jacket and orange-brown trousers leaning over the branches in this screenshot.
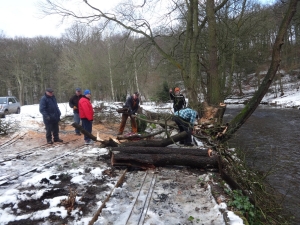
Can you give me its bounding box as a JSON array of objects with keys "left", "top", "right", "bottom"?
[{"left": 118, "top": 92, "right": 140, "bottom": 135}]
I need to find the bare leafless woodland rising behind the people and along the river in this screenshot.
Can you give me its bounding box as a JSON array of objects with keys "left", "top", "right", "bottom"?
[{"left": 0, "top": 0, "right": 300, "bottom": 224}]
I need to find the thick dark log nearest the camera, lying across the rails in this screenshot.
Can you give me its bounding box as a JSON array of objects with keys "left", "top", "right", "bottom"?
[{"left": 111, "top": 149, "right": 218, "bottom": 169}]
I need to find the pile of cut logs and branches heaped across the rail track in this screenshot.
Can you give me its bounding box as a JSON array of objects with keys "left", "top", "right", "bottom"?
[{"left": 72, "top": 108, "right": 226, "bottom": 169}]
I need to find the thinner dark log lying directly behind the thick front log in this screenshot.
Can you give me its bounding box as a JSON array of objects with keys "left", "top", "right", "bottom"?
[{"left": 111, "top": 147, "right": 210, "bottom": 156}]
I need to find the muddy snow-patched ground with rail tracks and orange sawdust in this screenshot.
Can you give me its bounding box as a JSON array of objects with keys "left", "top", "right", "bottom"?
[{"left": 0, "top": 119, "right": 234, "bottom": 225}]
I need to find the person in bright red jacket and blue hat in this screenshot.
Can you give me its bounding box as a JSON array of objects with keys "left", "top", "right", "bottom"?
[{"left": 78, "top": 90, "right": 94, "bottom": 145}]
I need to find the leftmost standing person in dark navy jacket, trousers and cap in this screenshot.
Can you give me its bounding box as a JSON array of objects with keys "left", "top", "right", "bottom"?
[{"left": 39, "top": 88, "right": 63, "bottom": 144}]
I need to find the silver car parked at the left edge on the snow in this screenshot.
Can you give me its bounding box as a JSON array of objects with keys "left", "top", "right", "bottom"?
[{"left": 0, "top": 96, "right": 21, "bottom": 118}]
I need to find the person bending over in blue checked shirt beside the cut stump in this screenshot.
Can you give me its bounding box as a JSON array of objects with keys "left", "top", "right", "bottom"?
[{"left": 174, "top": 108, "right": 198, "bottom": 146}]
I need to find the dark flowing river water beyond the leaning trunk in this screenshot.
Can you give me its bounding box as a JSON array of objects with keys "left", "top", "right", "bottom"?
[{"left": 224, "top": 105, "right": 300, "bottom": 224}]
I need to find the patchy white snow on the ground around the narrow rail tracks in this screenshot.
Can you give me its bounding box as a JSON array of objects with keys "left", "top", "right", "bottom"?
[{"left": 0, "top": 102, "right": 243, "bottom": 225}]
